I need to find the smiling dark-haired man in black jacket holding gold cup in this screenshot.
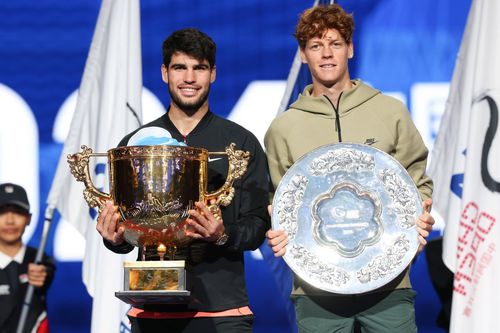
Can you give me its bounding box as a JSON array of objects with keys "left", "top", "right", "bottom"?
[{"left": 97, "top": 29, "right": 270, "bottom": 333}]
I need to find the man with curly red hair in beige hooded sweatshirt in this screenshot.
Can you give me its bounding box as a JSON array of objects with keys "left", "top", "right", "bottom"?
[{"left": 265, "top": 4, "right": 434, "bottom": 333}]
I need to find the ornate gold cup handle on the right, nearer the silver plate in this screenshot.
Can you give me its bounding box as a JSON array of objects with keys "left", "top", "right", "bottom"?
[{"left": 203, "top": 143, "right": 250, "bottom": 217}]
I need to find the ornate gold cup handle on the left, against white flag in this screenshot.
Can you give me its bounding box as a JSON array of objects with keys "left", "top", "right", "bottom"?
[{"left": 67, "top": 145, "right": 111, "bottom": 211}]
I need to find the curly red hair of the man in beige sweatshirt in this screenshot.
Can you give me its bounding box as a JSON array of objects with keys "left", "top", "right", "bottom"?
[{"left": 294, "top": 4, "right": 354, "bottom": 49}]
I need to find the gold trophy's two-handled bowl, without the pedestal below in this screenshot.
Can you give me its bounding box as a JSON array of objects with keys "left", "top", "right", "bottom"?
[{"left": 68, "top": 144, "right": 249, "bottom": 247}]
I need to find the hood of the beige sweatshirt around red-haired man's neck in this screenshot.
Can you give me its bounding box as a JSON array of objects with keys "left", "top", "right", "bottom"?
[{"left": 290, "top": 80, "right": 380, "bottom": 118}]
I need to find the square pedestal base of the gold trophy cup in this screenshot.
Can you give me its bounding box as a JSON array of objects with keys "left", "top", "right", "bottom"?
[{"left": 115, "top": 260, "right": 191, "bottom": 308}]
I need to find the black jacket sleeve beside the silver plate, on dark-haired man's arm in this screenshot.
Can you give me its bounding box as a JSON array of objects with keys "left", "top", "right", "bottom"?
[{"left": 223, "top": 136, "right": 270, "bottom": 251}]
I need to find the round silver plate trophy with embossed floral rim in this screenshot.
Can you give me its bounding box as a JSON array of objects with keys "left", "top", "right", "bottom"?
[{"left": 272, "top": 143, "right": 423, "bottom": 294}]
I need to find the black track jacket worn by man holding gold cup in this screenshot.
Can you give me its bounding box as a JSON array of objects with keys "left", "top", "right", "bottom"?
[{"left": 105, "top": 111, "right": 270, "bottom": 311}]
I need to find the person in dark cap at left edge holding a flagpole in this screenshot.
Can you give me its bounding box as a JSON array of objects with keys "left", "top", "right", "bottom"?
[{"left": 0, "top": 183, "right": 55, "bottom": 333}]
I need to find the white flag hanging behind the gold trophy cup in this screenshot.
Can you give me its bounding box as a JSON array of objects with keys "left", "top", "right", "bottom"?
[{"left": 47, "top": 0, "right": 142, "bottom": 333}]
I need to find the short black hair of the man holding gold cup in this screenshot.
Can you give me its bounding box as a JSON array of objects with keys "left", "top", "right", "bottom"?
[{"left": 162, "top": 28, "right": 216, "bottom": 68}]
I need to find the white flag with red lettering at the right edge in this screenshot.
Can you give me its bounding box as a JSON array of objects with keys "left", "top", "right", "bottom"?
[{"left": 429, "top": 0, "right": 500, "bottom": 332}]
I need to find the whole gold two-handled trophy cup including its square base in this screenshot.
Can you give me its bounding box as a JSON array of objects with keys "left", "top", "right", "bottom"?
[{"left": 68, "top": 143, "right": 250, "bottom": 307}]
